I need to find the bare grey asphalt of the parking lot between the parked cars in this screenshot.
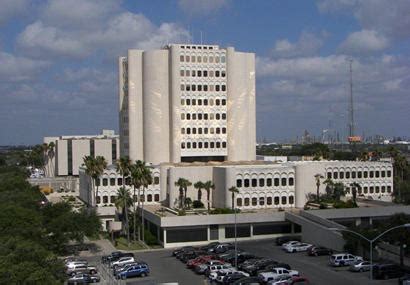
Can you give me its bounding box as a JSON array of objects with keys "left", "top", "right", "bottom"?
[{"left": 83, "top": 239, "right": 397, "bottom": 285}]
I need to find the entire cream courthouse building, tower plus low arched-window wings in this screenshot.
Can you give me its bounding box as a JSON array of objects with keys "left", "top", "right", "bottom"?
[{"left": 75, "top": 44, "right": 393, "bottom": 247}]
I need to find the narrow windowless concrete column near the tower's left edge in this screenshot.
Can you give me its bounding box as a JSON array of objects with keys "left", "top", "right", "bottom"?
[{"left": 128, "top": 50, "right": 144, "bottom": 161}]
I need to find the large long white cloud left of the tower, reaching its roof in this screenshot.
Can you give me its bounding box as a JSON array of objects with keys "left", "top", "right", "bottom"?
[{"left": 17, "top": 8, "right": 190, "bottom": 59}]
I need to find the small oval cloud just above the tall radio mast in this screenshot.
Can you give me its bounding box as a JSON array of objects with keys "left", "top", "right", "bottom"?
[{"left": 339, "top": 30, "right": 389, "bottom": 54}]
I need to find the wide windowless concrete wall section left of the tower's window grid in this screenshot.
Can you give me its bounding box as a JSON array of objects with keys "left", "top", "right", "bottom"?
[{"left": 143, "top": 50, "right": 170, "bottom": 164}]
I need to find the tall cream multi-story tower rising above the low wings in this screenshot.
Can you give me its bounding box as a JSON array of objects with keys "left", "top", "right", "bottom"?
[{"left": 119, "top": 44, "right": 256, "bottom": 164}]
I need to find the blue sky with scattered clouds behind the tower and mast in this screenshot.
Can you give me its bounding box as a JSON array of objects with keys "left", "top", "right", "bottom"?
[{"left": 0, "top": 0, "right": 410, "bottom": 145}]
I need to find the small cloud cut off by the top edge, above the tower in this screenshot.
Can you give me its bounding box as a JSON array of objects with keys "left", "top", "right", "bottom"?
[{"left": 178, "top": 0, "right": 229, "bottom": 16}]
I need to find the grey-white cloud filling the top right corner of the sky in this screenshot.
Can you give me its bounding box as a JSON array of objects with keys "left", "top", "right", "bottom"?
[{"left": 317, "top": 0, "right": 410, "bottom": 40}]
